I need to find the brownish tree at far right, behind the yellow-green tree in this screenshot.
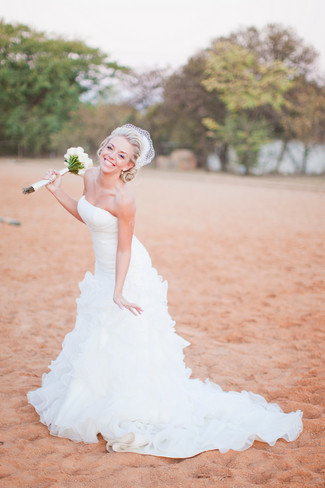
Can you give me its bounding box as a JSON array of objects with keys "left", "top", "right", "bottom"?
[{"left": 227, "top": 24, "right": 325, "bottom": 172}]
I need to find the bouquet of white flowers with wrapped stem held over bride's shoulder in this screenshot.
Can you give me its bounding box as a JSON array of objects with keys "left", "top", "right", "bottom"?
[{"left": 23, "top": 147, "right": 93, "bottom": 194}]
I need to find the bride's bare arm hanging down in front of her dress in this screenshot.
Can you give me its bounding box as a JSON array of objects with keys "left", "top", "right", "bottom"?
[{"left": 113, "top": 196, "right": 142, "bottom": 315}]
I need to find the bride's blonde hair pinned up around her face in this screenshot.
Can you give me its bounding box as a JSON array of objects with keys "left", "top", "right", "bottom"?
[{"left": 97, "top": 126, "right": 144, "bottom": 183}]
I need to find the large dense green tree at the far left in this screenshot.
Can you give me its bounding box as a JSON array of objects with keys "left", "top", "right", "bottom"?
[{"left": 0, "top": 20, "right": 120, "bottom": 154}]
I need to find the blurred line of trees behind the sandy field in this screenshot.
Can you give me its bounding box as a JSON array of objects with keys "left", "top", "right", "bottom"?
[{"left": 0, "top": 21, "right": 325, "bottom": 173}]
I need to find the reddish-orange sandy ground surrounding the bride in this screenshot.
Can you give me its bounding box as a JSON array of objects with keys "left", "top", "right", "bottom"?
[{"left": 0, "top": 160, "right": 325, "bottom": 488}]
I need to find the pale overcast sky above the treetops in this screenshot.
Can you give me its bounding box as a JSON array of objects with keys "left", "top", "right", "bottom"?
[{"left": 0, "top": 0, "right": 325, "bottom": 72}]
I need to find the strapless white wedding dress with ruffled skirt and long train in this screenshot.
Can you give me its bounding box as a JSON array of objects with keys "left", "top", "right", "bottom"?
[{"left": 28, "top": 196, "right": 302, "bottom": 458}]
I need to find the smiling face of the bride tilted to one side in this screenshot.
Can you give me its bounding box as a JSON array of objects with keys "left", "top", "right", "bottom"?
[{"left": 100, "top": 136, "right": 134, "bottom": 173}]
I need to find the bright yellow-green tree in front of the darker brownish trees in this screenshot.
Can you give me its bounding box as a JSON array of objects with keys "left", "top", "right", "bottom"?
[{"left": 202, "top": 40, "right": 294, "bottom": 174}]
